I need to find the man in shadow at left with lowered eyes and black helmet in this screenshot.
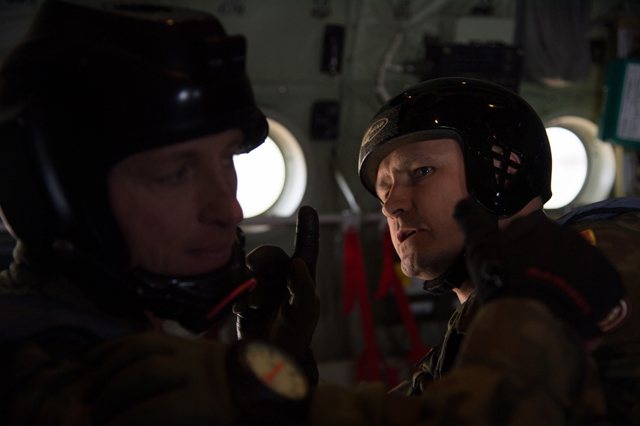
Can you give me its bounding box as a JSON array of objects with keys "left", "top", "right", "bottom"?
[{"left": 0, "top": 1, "right": 319, "bottom": 426}]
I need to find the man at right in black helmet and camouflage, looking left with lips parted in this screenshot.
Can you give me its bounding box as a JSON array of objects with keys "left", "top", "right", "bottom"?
[{"left": 359, "top": 78, "right": 640, "bottom": 425}]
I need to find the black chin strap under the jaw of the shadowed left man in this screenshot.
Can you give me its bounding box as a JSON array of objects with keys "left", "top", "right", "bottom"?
[{"left": 57, "top": 228, "right": 249, "bottom": 334}]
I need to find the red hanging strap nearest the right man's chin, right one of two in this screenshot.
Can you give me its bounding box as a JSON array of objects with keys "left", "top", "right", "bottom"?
[{"left": 376, "top": 227, "right": 429, "bottom": 364}]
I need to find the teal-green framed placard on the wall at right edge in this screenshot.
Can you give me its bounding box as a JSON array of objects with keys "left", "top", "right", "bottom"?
[{"left": 598, "top": 59, "right": 640, "bottom": 149}]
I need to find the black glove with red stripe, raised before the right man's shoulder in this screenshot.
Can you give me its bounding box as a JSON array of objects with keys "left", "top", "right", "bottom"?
[{"left": 454, "top": 199, "right": 624, "bottom": 339}]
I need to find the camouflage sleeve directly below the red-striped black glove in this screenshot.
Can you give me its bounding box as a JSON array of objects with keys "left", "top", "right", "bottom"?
[{"left": 423, "top": 298, "right": 605, "bottom": 426}]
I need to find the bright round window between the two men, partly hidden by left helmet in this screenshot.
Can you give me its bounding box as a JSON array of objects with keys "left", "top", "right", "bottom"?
[{"left": 233, "top": 118, "right": 307, "bottom": 219}]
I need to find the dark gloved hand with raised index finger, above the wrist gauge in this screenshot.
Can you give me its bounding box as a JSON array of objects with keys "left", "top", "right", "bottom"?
[{"left": 233, "top": 206, "right": 320, "bottom": 367}]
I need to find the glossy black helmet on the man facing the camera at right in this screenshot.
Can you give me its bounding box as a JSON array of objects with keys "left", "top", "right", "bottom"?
[{"left": 359, "top": 78, "right": 551, "bottom": 218}]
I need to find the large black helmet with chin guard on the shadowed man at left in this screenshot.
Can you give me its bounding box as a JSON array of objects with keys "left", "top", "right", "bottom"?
[{"left": 0, "top": 0, "right": 268, "bottom": 330}]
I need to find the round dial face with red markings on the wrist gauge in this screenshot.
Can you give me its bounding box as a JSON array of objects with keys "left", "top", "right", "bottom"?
[{"left": 244, "top": 342, "right": 309, "bottom": 400}]
